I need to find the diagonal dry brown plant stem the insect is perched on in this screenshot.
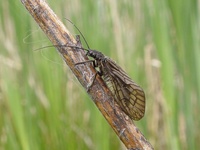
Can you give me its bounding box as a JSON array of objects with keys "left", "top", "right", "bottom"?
[{"left": 21, "top": 0, "right": 153, "bottom": 150}]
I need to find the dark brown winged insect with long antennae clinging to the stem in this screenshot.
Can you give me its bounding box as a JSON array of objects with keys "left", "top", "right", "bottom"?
[{"left": 67, "top": 19, "right": 145, "bottom": 120}]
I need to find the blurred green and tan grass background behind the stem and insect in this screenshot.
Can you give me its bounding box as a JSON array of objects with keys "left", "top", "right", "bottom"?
[{"left": 0, "top": 0, "right": 200, "bottom": 150}]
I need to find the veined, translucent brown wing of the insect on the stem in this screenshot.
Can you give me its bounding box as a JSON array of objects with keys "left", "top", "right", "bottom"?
[{"left": 103, "top": 58, "right": 145, "bottom": 120}]
